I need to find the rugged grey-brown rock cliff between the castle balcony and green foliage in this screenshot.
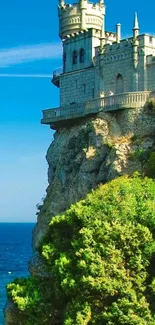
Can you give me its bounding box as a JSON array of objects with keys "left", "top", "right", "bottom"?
[{"left": 5, "top": 105, "right": 155, "bottom": 325}]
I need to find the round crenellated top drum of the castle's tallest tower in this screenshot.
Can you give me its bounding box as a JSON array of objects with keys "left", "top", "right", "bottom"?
[{"left": 58, "top": 0, "right": 105, "bottom": 39}]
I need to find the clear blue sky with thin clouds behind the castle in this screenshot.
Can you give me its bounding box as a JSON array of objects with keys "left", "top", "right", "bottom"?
[{"left": 0, "top": 0, "right": 155, "bottom": 222}]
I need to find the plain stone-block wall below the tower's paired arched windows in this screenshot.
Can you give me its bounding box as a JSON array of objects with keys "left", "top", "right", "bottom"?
[{"left": 60, "top": 67, "right": 95, "bottom": 106}]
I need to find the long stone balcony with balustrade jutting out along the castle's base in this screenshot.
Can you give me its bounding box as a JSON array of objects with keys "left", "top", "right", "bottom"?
[{"left": 41, "top": 91, "right": 151, "bottom": 129}]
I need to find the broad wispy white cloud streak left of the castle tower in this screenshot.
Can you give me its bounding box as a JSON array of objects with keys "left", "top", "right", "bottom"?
[{"left": 0, "top": 43, "right": 62, "bottom": 68}]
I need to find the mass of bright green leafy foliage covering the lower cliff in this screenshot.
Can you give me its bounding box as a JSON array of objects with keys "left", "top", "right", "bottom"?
[{"left": 8, "top": 176, "right": 155, "bottom": 325}]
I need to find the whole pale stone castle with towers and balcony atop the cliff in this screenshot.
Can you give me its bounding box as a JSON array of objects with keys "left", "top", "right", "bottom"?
[{"left": 42, "top": 0, "right": 155, "bottom": 129}]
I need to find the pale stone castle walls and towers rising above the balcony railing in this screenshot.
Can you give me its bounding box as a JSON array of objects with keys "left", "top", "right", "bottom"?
[{"left": 54, "top": 0, "right": 155, "bottom": 107}]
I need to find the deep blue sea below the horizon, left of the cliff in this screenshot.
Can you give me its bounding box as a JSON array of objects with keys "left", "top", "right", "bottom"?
[{"left": 0, "top": 223, "right": 34, "bottom": 325}]
